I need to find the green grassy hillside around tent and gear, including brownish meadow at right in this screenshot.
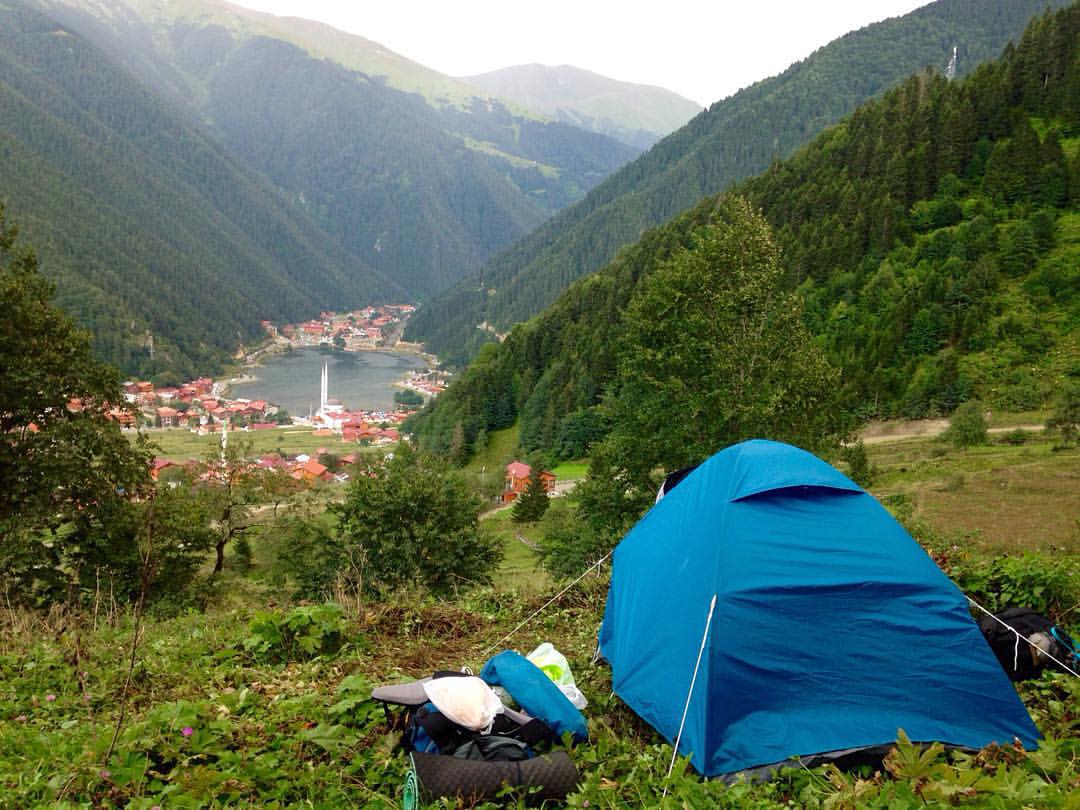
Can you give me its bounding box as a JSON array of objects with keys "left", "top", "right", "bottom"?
[{"left": 0, "top": 435, "right": 1080, "bottom": 809}]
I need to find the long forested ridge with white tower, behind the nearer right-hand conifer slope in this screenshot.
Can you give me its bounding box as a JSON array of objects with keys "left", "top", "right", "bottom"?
[{"left": 409, "top": 0, "right": 1065, "bottom": 363}]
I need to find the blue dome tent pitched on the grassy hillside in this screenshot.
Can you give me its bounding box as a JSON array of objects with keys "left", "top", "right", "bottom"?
[{"left": 599, "top": 440, "right": 1039, "bottom": 775}]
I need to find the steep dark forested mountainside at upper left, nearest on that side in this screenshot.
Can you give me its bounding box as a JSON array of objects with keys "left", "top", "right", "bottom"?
[{"left": 0, "top": 2, "right": 406, "bottom": 376}]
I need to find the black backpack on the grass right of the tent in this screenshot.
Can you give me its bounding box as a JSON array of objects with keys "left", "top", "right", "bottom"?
[{"left": 978, "top": 608, "right": 1080, "bottom": 680}]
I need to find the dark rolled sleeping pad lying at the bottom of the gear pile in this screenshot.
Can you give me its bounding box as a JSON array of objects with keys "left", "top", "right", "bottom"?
[{"left": 406, "top": 751, "right": 578, "bottom": 810}]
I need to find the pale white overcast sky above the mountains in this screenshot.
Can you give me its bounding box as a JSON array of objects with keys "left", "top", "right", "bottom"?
[{"left": 225, "top": 0, "right": 928, "bottom": 105}]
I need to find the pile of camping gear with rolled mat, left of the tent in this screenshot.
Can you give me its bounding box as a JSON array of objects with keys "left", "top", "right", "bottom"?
[{"left": 372, "top": 645, "right": 589, "bottom": 810}]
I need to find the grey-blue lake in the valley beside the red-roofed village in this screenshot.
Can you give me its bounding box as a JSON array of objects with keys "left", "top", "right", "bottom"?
[{"left": 231, "top": 349, "right": 427, "bottom": 417}]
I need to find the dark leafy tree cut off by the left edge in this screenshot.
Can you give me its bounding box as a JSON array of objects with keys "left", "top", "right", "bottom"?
[{"left": 0, "top": 207, "right": 151, "bottom": 600}]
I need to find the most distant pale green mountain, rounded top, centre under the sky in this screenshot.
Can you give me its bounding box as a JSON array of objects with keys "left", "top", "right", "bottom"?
[{"left": 461, "top": 65, "right": 701, "bottom": 149}]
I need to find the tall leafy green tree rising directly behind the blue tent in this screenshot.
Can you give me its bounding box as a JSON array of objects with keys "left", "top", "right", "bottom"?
[{"left": 581, "top": 197, "right": 843, "bottom": 530}]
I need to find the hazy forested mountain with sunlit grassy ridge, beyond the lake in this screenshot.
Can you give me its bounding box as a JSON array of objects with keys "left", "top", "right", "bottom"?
[{"left": 29, "top": 0, "right": 639, "bottom": 296}]
